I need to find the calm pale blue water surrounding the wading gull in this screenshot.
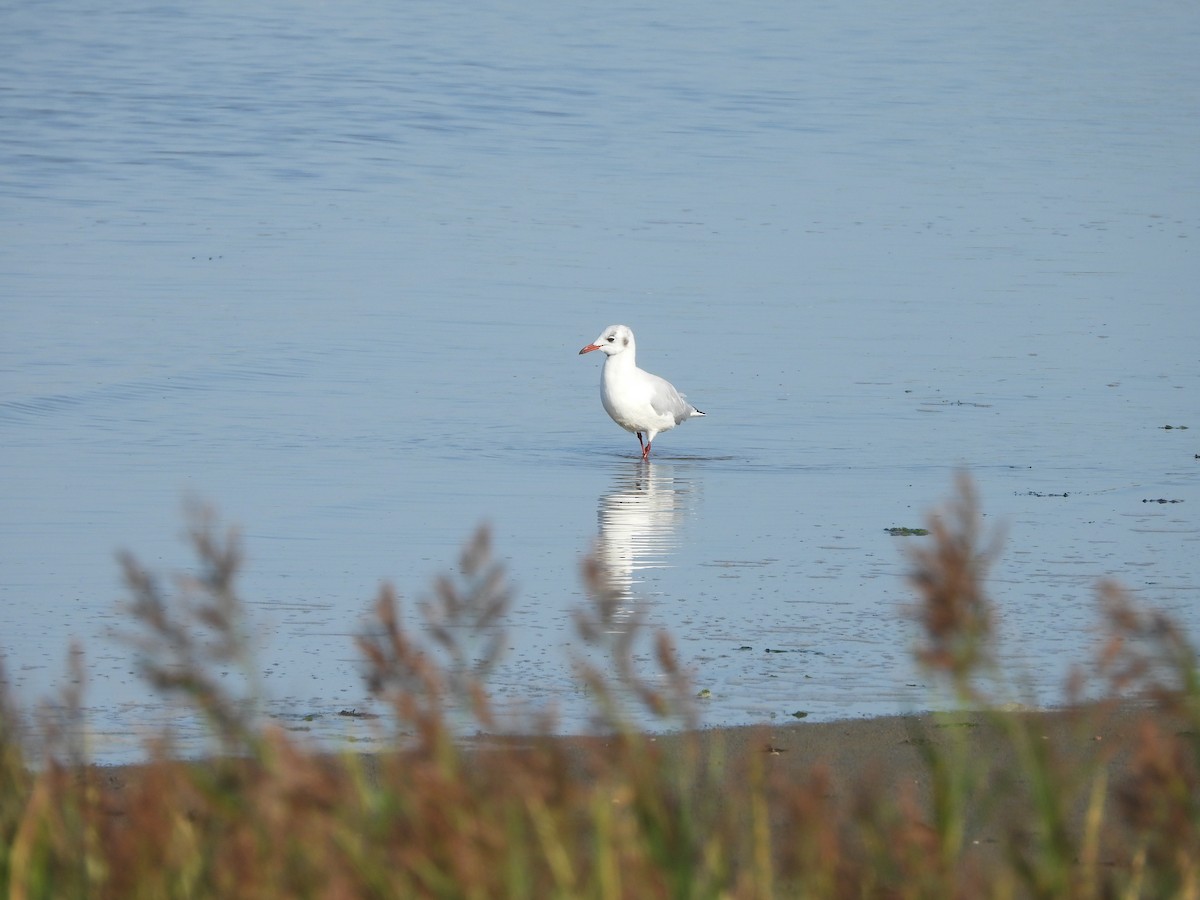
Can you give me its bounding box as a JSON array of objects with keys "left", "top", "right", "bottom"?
[{"left": 0, "top": 0, "right": 1200, "bottom": 760}]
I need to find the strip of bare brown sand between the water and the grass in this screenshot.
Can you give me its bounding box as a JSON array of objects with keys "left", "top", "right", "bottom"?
[{"left": 91, "top": 702, "right": 1180, "bottom": 859}]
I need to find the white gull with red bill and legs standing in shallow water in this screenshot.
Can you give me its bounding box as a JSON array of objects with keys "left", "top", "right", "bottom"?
[{"left": 580, "top": 325, "right": 703, "bottom": 460}]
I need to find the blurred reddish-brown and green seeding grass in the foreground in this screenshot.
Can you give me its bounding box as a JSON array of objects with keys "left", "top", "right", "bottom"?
[{"left": 0, "top": 481, "right": 1200, "bottom": 899}]
